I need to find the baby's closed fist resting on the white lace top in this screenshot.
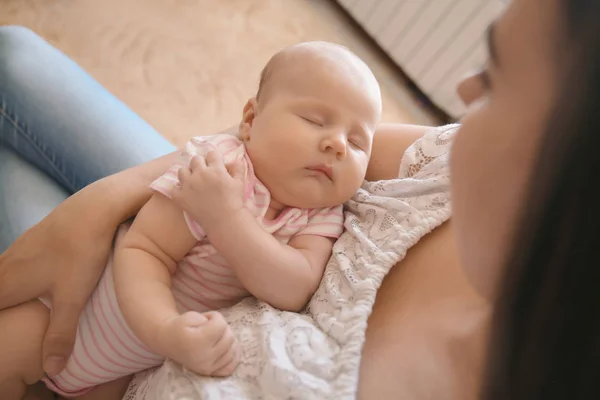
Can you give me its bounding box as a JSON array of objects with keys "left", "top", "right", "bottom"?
[{"left": 159, "top": 311, "right": 239, "bottom": 376}]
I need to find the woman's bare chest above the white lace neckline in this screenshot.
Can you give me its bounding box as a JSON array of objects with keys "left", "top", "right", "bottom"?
[{"left": 358, "top": 222, "right": 489, "bottom": 400}]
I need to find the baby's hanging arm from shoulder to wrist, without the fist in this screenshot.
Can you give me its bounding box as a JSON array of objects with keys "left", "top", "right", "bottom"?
[{"left": 113, "top": 194, "right": 196, "bottom": 355}]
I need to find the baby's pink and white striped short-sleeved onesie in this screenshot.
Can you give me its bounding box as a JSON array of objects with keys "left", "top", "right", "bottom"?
[{"left": 42, "top": 135, "right": 343, "bottom": 397}]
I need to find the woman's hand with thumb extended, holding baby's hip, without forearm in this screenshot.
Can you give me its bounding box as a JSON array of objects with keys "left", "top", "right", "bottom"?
[{"left": 0, "top": 202, "right": 114, "bottom": 374}]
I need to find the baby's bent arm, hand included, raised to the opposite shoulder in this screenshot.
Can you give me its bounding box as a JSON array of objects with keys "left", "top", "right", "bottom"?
[{"left": 172, "top": 147, "right": 343, "bottom": 311}]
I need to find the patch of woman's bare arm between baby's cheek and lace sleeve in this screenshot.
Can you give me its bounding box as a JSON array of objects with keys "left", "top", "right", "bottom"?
[{"left": 366, "top": 124, "right": 430, "bottom": 181}]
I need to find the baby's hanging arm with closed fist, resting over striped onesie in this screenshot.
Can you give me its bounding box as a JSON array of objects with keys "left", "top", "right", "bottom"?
[{"left": 113, "top": 194, "right": 237, "bottom": 376}]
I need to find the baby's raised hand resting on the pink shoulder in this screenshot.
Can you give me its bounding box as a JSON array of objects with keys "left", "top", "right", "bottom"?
[{"left": 172, "top": 152, "right": 244, "bottom": 230}]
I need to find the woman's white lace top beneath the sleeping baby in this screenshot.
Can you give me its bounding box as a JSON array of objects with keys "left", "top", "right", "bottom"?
[{"left": 125, "top": 125, "right": 456, "bottom": 400}]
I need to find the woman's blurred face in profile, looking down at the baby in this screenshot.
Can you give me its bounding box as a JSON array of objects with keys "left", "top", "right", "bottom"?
[{"left": 451, "top": 0, "right": 560, "bottom": 299}]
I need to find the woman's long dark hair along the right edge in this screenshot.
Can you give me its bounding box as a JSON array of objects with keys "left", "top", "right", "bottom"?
[{"left": 482, "top": 0, "right": 600, "bottom": 400}]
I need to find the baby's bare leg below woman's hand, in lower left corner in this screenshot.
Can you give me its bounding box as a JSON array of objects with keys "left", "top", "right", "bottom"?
[{"left": 0, "top": 300, "right": 50, "bottom": 400}]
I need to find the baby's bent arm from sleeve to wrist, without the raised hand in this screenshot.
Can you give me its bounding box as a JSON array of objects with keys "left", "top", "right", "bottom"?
[{"left": 205, "top": 209, "right": 334, "bottom": 311}]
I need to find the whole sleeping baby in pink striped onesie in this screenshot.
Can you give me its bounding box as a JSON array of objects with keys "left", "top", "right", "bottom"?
[{"left": 0, "top": 42, "right": 381, "bottom": 399}]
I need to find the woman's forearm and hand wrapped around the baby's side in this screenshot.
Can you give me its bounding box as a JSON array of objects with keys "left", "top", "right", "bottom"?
[{"left": 0, "top": 148, "right": 177, "bottom": 373}]
